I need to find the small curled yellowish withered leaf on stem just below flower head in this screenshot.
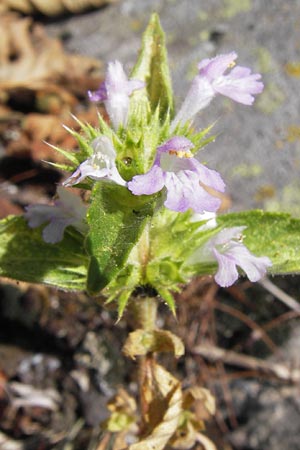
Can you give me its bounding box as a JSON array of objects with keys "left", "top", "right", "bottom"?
[{"left": 123, "top": 329, "right": 184, "bottom": 359}]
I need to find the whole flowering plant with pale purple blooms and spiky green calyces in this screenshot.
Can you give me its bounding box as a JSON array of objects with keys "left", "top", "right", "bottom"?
[{"left": 0, "top": 15, "right": 300, "bottom": 449}]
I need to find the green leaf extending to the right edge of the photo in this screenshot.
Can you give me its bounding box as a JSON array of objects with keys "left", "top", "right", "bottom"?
[{"left": 217, "top": 211, "right": 300, "bottom": 274}]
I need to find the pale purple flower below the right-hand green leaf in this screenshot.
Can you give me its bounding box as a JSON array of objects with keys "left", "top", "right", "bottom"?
[{"left": 189, "top": 226, "right": 272, "bottom": 287}]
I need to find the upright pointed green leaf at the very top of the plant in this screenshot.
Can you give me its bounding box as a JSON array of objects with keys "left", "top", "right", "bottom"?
[{"left": 131, "top": 14, "right": 173, "bottom": 116}]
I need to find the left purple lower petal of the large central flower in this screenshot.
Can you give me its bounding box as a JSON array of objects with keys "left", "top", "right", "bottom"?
[{"left": 127, "top": 165, "right": 165, "bottom": 195}]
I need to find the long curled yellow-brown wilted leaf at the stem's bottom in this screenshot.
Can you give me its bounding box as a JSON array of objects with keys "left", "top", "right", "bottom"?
[{"left": 128, "top": 360, "right": 182, "bottom": 450}]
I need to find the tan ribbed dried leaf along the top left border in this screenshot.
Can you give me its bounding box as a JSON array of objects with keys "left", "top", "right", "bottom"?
[{"left": 0, "top": 0, "right": 114, "bottom": 17}]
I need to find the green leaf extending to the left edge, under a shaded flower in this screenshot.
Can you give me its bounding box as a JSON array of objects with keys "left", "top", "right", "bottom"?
[{"left": 0, "top": 216, "right": 88, "bottom": 291}]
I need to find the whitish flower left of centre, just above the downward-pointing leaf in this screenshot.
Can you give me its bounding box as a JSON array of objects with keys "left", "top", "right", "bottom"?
[{"left": 63, "top": 136, "right": 126, "bottom": 186}]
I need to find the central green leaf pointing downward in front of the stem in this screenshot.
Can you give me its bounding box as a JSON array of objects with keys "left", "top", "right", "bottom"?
[{"left": 87, "top": 182, "right": 153, "bottom": 294}]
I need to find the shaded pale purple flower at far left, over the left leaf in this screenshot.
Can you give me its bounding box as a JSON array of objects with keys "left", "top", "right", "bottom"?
[{"left": 24, "top": 186, "right": 87, "bottom": 244}]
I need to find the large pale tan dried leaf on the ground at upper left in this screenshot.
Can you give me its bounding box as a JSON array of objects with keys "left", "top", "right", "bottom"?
[{"left": 0, "top": 14, "right": 101, "bottom": 97}]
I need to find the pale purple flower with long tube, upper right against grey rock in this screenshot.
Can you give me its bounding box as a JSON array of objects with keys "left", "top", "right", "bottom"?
[{"left": 172, "top": 52, "right": 264, "bottom": 129}]
